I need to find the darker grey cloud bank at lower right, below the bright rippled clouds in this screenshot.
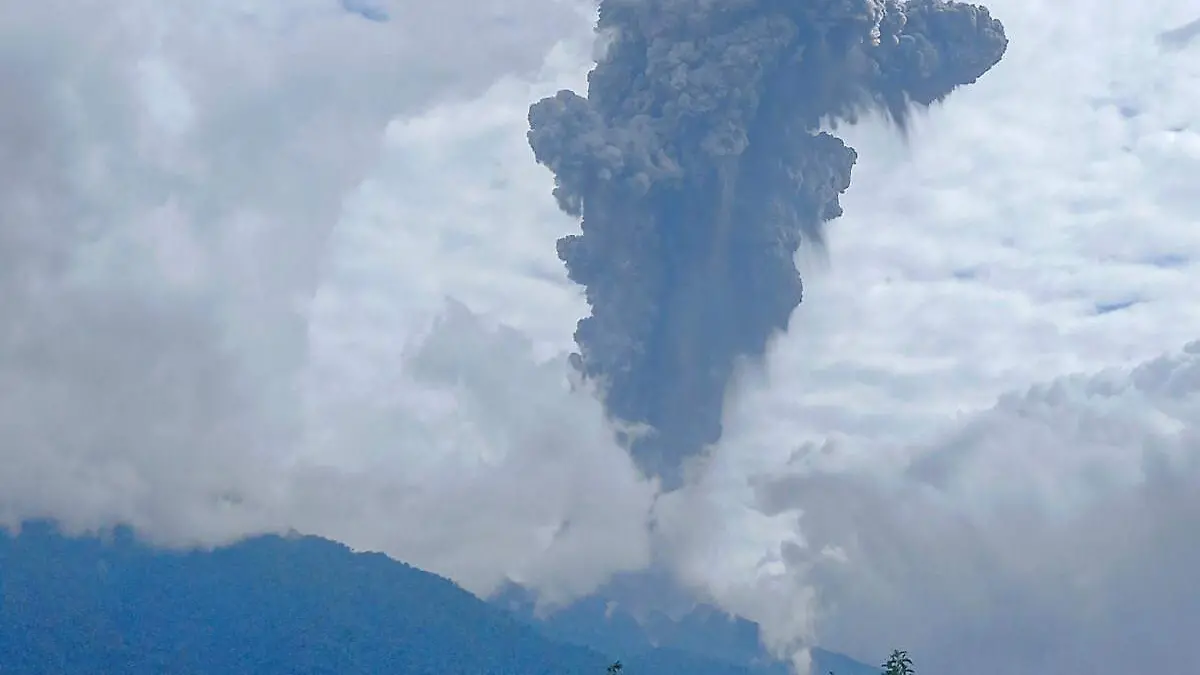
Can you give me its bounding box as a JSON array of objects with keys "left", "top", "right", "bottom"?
[{"left": 660, "top": 344, "right": 1200, "bottom": 675}]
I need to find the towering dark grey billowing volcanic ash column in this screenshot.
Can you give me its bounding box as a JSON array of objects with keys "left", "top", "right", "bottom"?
[{"left": 529, "top": 0, "right": 1008, "bottom": 486}]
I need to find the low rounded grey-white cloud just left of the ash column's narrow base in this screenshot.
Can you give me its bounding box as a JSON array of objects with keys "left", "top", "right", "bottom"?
[{"left": 286, "top": 299, "right": 654, "bottom": 602}]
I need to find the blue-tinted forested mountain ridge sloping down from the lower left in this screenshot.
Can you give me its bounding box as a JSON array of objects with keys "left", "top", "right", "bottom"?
[{"left": 0, "top": 521, "right": 873, "bottom": 675}]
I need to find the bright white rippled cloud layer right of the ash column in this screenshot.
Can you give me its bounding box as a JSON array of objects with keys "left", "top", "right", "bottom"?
[{"left": 773, "top": 0, "right": 1200, "bottom": 440}]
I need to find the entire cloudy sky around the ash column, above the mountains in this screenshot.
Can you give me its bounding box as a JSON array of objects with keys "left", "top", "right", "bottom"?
[{"left": 0, "top": 0, "right": 1200, "bottom": 675}]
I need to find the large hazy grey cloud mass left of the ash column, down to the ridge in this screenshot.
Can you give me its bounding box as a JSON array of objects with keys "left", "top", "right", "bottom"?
[{"left": 0, "top": 0, "right": 653, "bottom": 597}]
